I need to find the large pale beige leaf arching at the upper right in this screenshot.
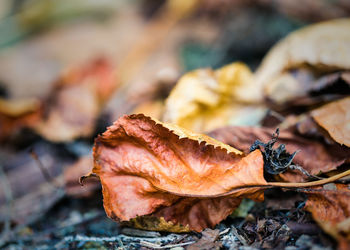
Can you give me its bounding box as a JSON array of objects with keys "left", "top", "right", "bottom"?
[{"left": 254, "top": 18, "right": 350, "bottom": 94}]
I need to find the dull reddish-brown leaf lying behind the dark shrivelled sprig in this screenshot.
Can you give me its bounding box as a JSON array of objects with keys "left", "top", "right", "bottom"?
[{"left": 209, "top": 127, "right": 350, "bottom": 182}]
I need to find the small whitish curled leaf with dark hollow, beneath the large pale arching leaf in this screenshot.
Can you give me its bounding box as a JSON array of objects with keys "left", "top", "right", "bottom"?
[{"left": 265, "top": 66, "right": 350, "bottom": 113}]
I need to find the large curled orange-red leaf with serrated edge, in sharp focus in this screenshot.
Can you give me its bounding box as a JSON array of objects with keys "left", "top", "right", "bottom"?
[{"left": 93, "top": 115, "right": 266, "bottom": 231}]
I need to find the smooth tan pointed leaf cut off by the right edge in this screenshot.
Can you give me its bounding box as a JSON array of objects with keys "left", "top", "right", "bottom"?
[{"left": 311, "top": 97, "right": 350, "bottom": 147}]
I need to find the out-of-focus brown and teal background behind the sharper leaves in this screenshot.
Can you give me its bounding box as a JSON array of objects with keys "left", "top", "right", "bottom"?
[{"left": 0, "top": 0, "right": 350, "bottom": 247}]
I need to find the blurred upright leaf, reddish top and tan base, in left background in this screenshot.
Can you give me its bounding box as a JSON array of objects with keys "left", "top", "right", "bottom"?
[{"left": 33, "top": 59, "right": 116, "bottom": 142}]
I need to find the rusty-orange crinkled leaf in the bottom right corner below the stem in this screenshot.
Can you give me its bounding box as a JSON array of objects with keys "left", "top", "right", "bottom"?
[{"left": 305, "top": 184, "right": 350, "bottom": 249}]
